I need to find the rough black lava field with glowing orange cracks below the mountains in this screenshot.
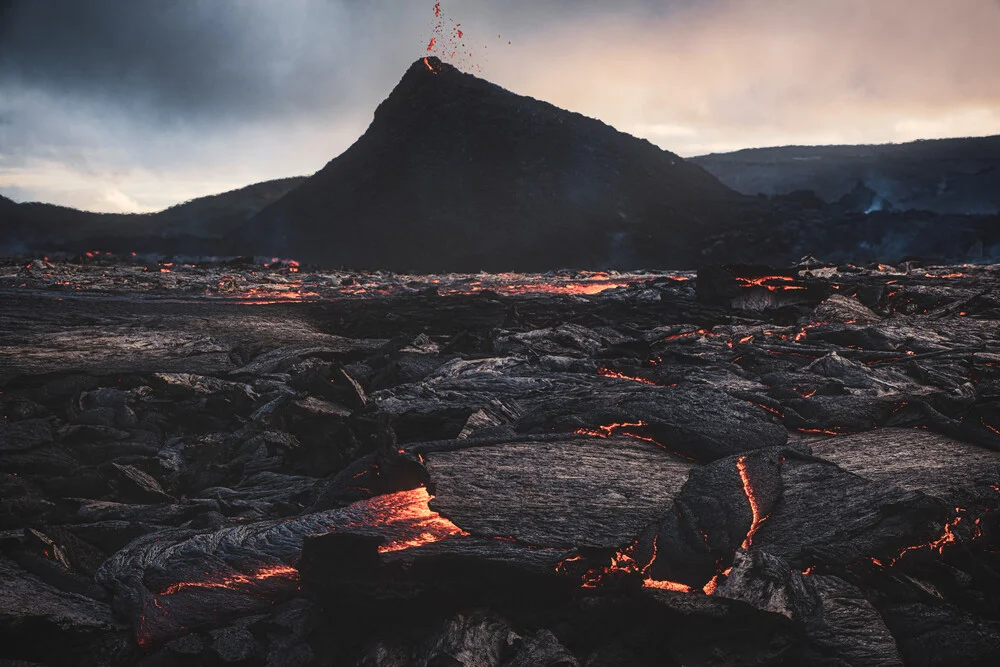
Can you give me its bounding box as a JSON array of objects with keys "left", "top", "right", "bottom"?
[{"left": 0, "top": 254, "right": 1000, "bottom": 667}]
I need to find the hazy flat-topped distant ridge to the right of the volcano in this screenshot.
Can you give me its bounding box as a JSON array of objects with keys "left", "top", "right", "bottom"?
[{"left": 691, "top": 135, "right": 1000, "bottom": 215}]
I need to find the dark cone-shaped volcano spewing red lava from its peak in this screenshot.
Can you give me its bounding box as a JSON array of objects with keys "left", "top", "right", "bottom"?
[{"left": 246, "top": 57, "right": 743, "bottom": 271}]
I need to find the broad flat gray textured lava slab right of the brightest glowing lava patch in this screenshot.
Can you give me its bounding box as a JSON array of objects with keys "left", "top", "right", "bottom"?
[{"left": 424, "top": 437, "right": 692, "bottom": 547}]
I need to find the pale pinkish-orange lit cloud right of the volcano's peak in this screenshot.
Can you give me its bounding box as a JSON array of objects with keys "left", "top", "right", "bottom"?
[{"left": 488, "top": 0, "right": 1000, "bottom": 154}]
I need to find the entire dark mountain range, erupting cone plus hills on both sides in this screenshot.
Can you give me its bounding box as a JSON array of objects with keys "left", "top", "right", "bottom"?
[{"left": 0, "top": 57, "right": 1000, "bottom": 272}]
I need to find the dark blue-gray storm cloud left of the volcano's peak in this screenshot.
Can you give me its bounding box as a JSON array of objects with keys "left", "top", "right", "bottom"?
[{"left": 0, "top": 0, "right": 404, "bottom": 122}]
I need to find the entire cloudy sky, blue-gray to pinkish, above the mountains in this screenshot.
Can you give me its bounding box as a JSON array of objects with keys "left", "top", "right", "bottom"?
[{"left": 0, "top": 0, "right": 1000, "bottom": 212}]
